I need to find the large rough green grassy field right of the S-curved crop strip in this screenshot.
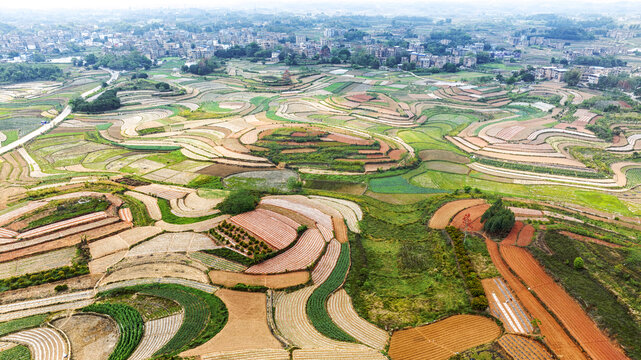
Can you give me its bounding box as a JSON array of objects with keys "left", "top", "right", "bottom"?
[{"left": 345, "top": 198, "right": 470, "bottom": 329}]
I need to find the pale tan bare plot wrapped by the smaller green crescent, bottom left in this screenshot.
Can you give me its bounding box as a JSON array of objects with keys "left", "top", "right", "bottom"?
[{"left": 53, "top": 314, "right": 119, "bottom": 360}]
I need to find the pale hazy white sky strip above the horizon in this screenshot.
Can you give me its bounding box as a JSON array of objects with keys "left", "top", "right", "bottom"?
[{"left": 0, "top": 0, "right": 639, "bottom": 12}]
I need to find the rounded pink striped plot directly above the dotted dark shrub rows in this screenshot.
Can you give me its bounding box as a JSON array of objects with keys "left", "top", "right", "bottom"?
[{"left": 229, "top": 209, "right": 300, "bottom": 250}]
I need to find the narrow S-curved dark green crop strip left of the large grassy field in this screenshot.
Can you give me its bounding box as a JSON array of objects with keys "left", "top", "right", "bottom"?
[{"left": 306, "top": 243, "right": 356, "bottom": 342}]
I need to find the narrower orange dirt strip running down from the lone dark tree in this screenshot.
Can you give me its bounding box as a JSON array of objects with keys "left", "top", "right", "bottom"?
[{"left": 485, "top": 237, "right": 587, "bottom": 360}]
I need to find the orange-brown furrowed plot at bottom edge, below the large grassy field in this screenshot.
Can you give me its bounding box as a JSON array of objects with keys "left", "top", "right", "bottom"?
[{"left": 389, "top": 315, "right": 501, "bottom": 360}]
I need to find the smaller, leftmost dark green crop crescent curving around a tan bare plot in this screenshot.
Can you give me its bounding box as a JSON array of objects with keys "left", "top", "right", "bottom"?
[{"left": 82, "top": 303, "right": 145, "bottom": 360}]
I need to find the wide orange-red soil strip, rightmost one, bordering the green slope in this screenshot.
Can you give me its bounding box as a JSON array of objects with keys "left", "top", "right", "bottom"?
[{"left": 500, "top": 246, "right": 627, "bottom": 360}]
